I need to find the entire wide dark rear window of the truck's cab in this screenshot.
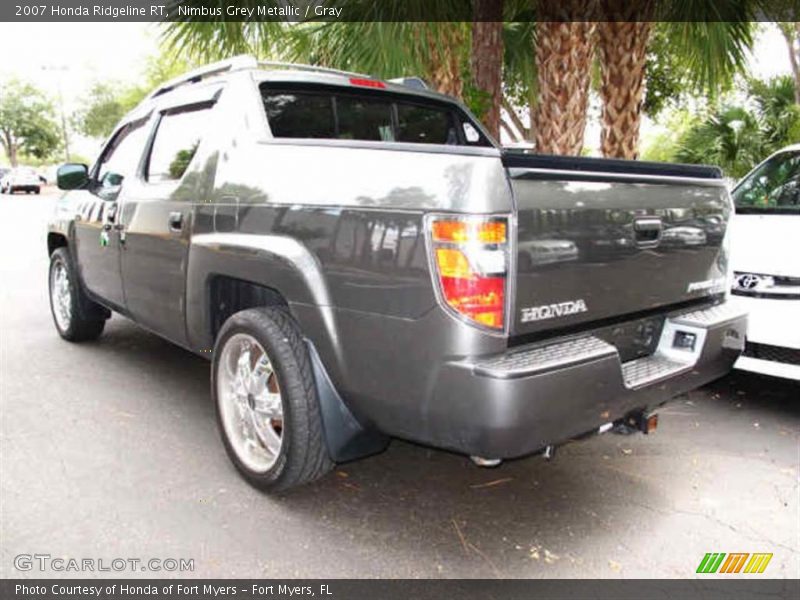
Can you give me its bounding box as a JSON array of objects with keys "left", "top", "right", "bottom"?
[{"left": 261, "top": 84, "right": 491, "bottom": 146}]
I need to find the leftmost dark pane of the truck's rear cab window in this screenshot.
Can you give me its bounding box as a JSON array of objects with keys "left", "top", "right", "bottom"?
[{"left": 263, "top": 93, "right": 336, "bottom": 139}]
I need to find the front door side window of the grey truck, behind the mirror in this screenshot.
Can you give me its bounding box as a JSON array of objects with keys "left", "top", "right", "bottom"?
[{"left": 95, "top": 119, "right": 148, "bottom": 200}]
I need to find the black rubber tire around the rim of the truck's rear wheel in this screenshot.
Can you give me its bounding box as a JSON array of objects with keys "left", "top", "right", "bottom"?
[{"left": 211, "top": 307, "right": 334, "bottom": 492}]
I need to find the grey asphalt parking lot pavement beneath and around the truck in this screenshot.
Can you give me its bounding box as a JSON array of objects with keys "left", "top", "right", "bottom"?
[{"left": 0, "top": 190, "right": 800, "bottom": 578}]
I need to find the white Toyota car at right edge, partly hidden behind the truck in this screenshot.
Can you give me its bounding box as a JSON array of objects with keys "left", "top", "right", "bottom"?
[{"left": 731, "top": 144, "right": 800, "bottom": 380}]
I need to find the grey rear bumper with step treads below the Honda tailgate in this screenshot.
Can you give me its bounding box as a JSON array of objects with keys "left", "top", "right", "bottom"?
[{"left": 427, "top": 304, "right": 747, "bottom": 458}]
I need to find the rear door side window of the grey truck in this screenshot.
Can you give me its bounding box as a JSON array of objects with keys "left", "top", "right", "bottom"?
[{"left": 145, "top": 108, "right": 211, "bottom": 183}]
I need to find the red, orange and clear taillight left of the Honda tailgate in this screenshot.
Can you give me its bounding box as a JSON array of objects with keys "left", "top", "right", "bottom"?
[{"left": 429, "top": 217, "right": 508, "bottom": 330}]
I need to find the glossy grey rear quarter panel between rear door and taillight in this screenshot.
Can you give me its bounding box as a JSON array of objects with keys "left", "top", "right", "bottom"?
[{"left": 187, "top": 143, "right": 512, "bottom": 433}]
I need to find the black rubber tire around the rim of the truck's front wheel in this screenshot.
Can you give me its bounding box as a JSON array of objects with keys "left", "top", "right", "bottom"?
[{"left": 48, "top": 247, "right": 110, "bottom": 342}]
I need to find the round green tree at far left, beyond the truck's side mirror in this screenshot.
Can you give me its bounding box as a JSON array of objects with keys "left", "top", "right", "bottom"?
[{"left": 0, "top": 79, "right": 61, "bottom": 167}]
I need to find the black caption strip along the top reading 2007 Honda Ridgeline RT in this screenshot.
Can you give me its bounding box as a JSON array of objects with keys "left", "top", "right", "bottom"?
[{"left": 0, "top": 0, "right": 800, "bottom": 23}]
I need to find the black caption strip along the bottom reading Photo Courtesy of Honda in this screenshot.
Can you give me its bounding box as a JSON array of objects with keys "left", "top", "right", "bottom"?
[{"left": 0, "top": 576, "right": 800, "bottom": 600}]
